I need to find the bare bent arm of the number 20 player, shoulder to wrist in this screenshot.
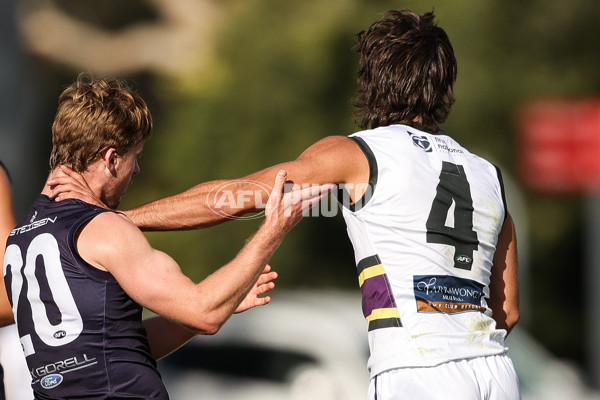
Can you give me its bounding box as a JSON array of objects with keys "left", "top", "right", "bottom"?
[{"left": 77, "top": 213, "right": 281, "bottom": 334}]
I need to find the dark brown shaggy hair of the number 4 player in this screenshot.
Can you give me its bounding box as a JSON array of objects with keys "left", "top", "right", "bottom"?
[{"left": 354, "top": 10, "right": 457, "bottom": 129}]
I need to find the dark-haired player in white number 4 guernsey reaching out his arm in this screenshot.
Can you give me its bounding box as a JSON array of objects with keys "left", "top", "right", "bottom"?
[{"left": 50, "top": 10, "right": 521, "bottom": 400}]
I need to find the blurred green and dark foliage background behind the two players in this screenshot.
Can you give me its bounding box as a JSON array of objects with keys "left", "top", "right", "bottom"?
[{"left": 0, "top": 0, "right": 600, "bottom": 386}]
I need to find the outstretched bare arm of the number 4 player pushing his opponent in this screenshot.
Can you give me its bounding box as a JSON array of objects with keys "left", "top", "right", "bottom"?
[{"left": 125, "top": 136, "right": 369, "bottom": 230}]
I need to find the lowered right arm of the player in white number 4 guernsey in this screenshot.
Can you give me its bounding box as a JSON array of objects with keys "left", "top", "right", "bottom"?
[{"left": 488, "top": 214, "right": 520, "bottom": 333}]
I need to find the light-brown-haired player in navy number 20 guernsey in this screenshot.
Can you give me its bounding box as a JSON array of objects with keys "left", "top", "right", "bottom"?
[{"left": 4, "top": 75, "right": 331, "bottom": 400}]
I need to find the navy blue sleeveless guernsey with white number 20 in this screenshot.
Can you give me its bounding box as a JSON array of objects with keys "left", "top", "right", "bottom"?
[{"left": 4, "top": 195, "right": 168, "bottom": 399}]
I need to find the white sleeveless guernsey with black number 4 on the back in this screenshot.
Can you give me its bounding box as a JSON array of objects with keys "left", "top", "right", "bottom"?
[{"left": 340, "top": 125, "right": 506, "bottom": 377}]
